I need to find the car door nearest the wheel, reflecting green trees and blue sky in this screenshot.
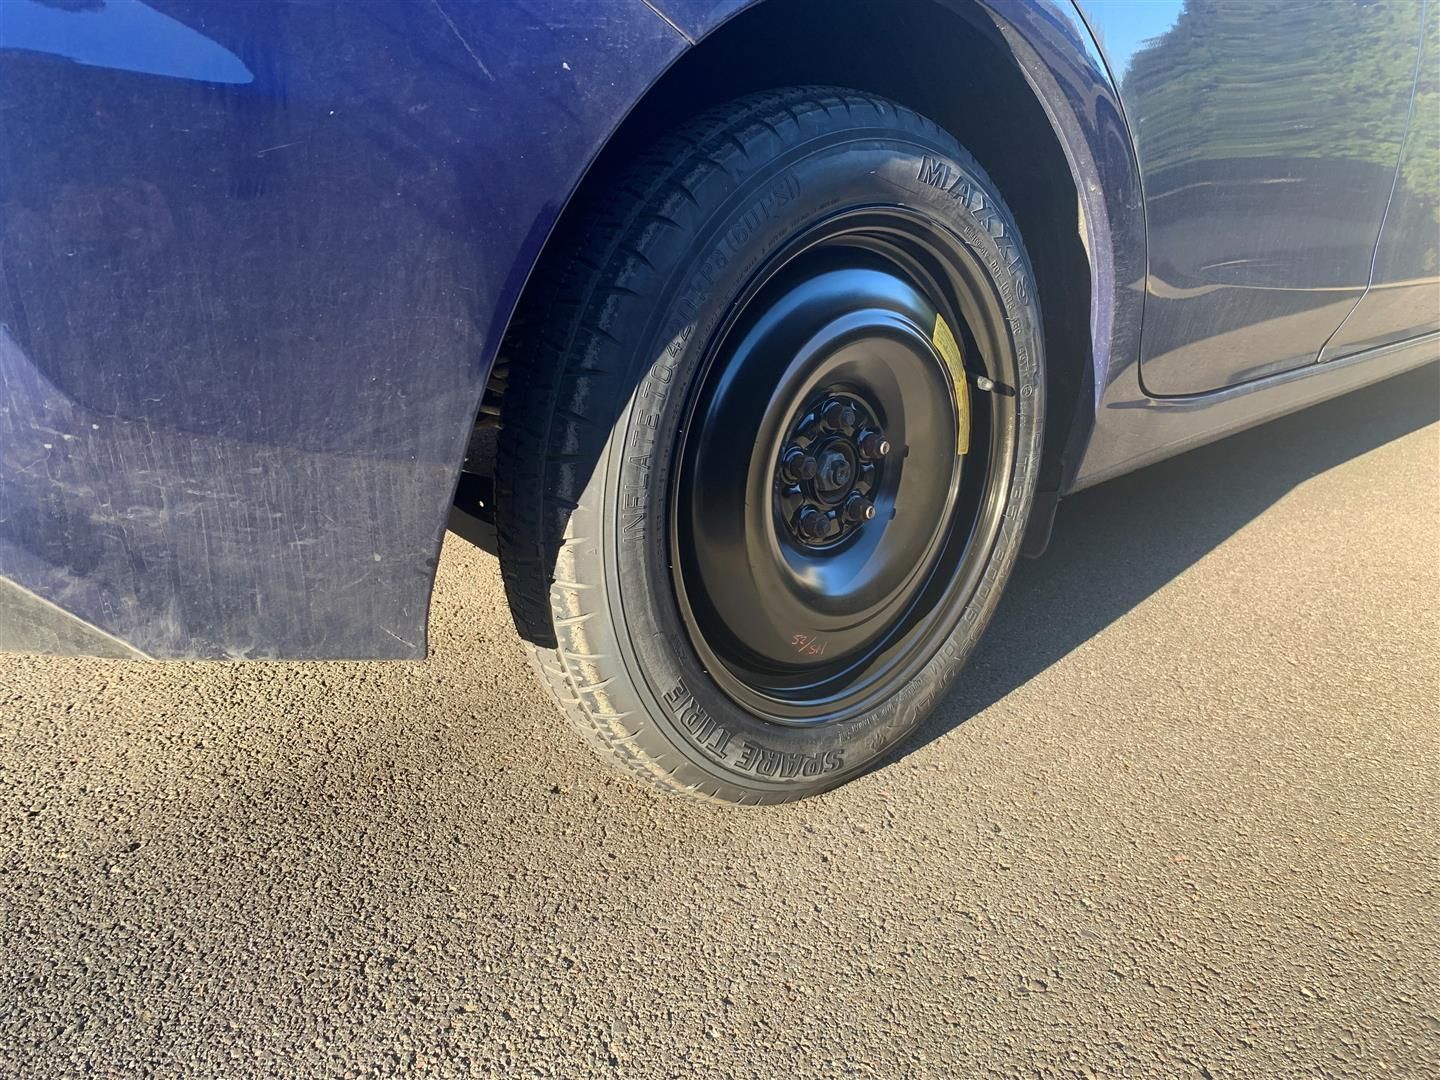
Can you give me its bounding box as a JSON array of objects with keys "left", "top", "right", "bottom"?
[{"left": 1083, "top": 0, "right": 1424, "bottom": 396}]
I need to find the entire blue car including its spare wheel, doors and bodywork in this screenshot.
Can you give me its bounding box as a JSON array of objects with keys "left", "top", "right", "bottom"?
[{"left": 0, "top": 0, "right": 1440, "bottom": 804}]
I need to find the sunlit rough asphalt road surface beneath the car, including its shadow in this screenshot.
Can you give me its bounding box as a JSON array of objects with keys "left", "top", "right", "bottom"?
[{"left": 8, "top": 367, "right": 1440, "bottom": 1080}]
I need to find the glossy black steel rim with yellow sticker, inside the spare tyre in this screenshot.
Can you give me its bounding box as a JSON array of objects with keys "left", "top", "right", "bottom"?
[{"left": 671, "top": 207, "right": 1017, "bottom": 724}]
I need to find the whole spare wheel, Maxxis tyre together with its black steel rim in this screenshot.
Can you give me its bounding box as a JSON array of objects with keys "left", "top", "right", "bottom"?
[{"left": 497, "top": 88, "right": 1043, "bottom": 802}]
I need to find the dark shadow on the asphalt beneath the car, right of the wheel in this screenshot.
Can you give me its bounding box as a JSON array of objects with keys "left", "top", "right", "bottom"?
[{"left": 897, "top": 364, "right": 1440, "bottom": 756}]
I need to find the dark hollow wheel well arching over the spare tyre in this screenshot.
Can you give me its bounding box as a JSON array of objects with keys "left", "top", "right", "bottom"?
[{"left": 465, "top": 0, "right": 1092, "bottom": 506}]
